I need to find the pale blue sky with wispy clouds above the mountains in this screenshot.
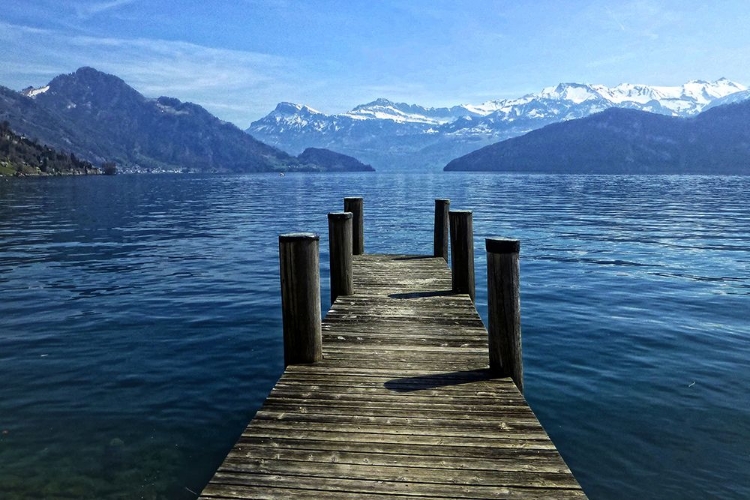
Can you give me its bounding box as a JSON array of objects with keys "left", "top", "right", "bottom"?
[{"left": 0, "top": 0, "right": 750, "bottom": 128}]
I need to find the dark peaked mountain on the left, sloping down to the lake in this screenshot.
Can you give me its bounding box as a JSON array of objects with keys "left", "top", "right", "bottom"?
[{"left": 0, "top": 68, "right": 372, "bottom": 172}]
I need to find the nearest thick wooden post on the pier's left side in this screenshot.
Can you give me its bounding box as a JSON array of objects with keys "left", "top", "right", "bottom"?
[{"left": 279, "top": 233, "right": 323, "bottom": 366}]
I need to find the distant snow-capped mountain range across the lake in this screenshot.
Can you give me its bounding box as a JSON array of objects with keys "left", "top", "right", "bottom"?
[{"left": 247, "top": 78, "right": 747, "bottom": 170}]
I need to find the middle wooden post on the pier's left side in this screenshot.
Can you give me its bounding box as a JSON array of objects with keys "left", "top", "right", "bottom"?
[{"left": 328, "top": 212, "right": 354, "bottom": 304}]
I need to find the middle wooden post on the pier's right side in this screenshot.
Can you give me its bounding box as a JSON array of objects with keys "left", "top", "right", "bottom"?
[{"left": 448, "top": 210, "right": 476, "bottom": 302}]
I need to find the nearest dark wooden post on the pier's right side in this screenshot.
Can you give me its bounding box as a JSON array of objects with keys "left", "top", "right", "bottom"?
[{"left": 485, "top": 238, "right": 523, "bottom": 392}]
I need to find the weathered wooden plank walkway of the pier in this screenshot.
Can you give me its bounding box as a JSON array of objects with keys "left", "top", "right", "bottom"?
[{"left": 201, "top": 255, "right": 585, "bottom": 500}]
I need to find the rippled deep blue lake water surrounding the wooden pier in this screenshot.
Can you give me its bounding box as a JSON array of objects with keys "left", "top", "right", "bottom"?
[{"left": 0, "top": 173, "right": 750, "bottom": 499}]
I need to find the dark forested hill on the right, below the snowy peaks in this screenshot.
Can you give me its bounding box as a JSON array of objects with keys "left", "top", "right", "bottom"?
[{"left": 445, "top": 101, "right": 750, "bottom": 175}]
